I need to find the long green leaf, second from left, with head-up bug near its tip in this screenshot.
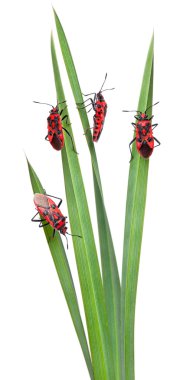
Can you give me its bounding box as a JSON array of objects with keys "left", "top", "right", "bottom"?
[{"left": 51, "top": 35, "right": 114, "bottom": 380}]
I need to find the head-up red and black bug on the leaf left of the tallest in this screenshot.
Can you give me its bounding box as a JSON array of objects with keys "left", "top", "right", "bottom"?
[{"left": 34, "top": 101, "right": 77, "bottom": 153}]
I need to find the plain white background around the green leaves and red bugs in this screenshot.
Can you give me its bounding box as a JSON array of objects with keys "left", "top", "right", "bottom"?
[{"left": 0, "top": 0, "right": 183, "bottom": 380}]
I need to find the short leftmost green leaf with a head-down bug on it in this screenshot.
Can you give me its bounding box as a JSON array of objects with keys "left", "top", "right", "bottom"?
[{"left": 27, "top": 161, "right": 94, "bottom": 380}]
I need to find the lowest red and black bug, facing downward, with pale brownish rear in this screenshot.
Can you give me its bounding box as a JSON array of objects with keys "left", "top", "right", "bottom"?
[{"left": 31, "top": 193, "right": 82, "bottom": 248}]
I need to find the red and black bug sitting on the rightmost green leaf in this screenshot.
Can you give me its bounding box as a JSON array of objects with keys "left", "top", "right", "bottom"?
[{"left": 123, "top": 102, "right": 160, "bottom": 161}]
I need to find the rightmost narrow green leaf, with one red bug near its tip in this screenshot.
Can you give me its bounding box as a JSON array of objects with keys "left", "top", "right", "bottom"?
[{"left": 121, "top": 37, "right": 154, "bottom": 380}]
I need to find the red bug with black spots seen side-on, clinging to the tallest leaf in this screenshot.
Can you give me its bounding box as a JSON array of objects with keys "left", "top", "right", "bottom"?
[{"left": 77, "top": 74, "right": 114, "bottom": 142}]
